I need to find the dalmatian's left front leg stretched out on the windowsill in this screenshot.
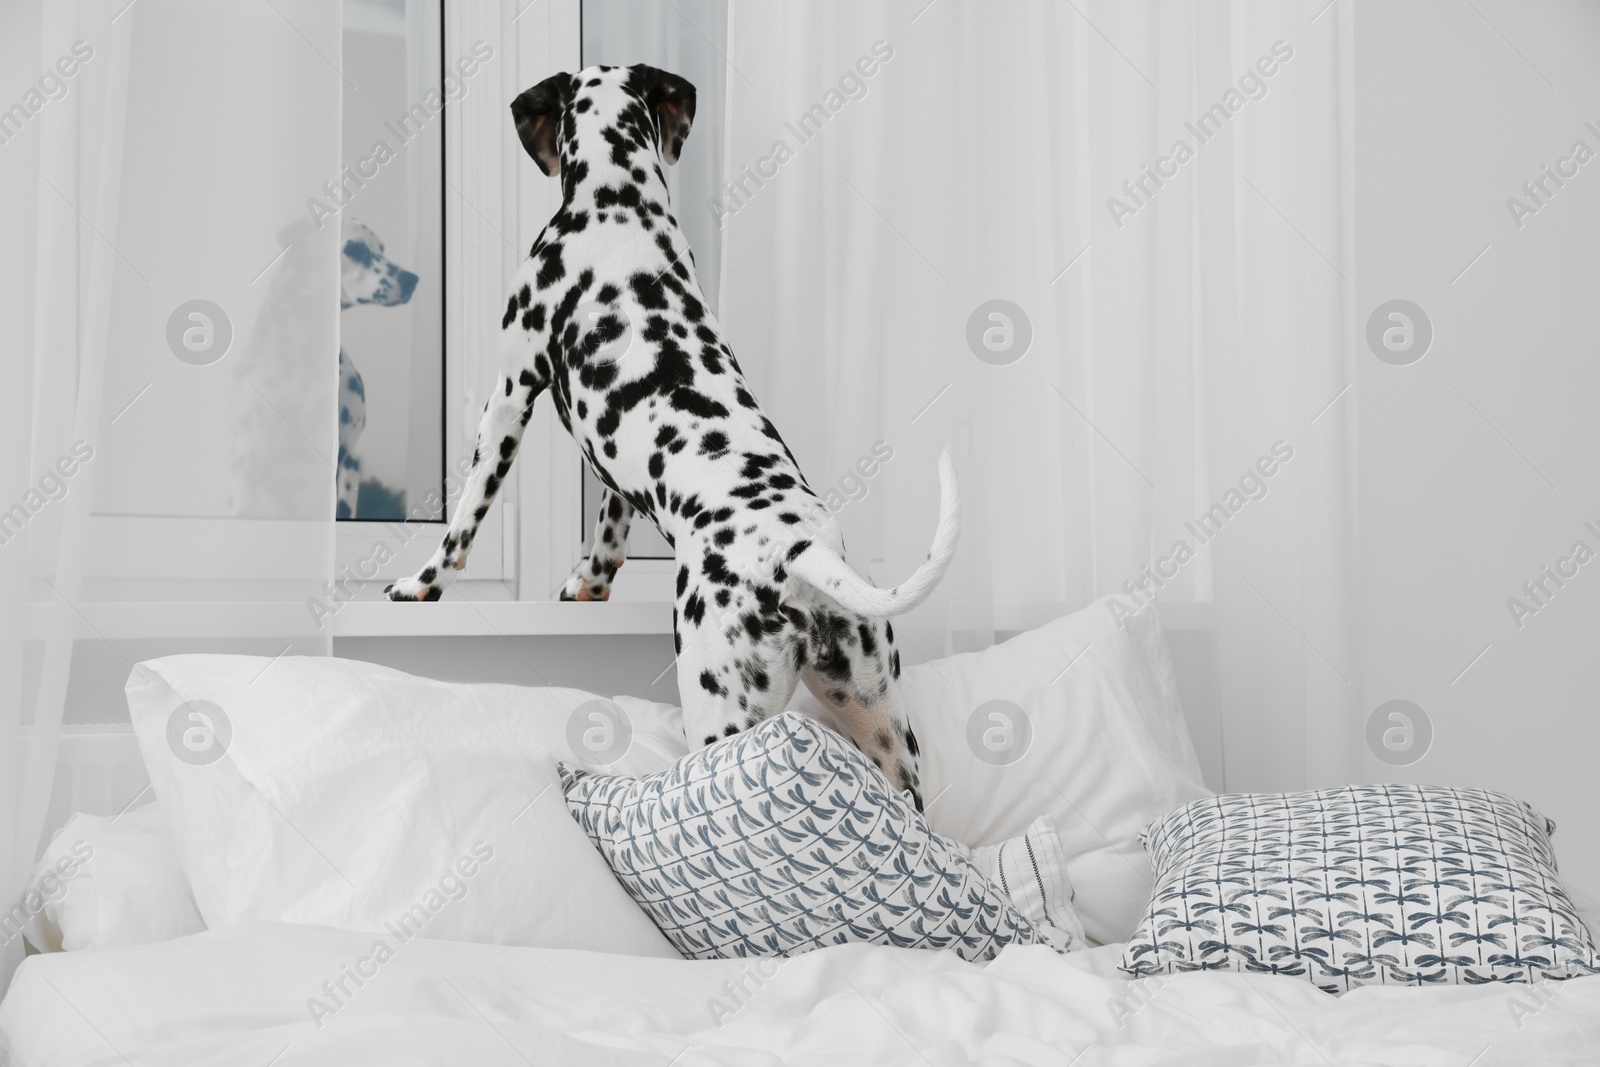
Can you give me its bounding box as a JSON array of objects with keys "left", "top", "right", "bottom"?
[{"left": 384, "top": 329, "right": 549, "bottom": 600}]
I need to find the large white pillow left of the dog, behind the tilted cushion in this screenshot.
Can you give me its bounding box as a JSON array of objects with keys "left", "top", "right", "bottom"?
[{"left": 128, "top": 656, "right": 686, "bottom": 958}]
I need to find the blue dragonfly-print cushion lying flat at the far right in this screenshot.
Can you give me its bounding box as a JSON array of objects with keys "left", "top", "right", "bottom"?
[{"left": 1122, "top": 785, "right": 1600, "bottom": 992}]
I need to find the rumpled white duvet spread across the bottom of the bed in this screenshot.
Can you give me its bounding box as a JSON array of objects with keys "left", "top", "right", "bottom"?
[{"left": 0, "top": 923, "right": 1600, "bottom": 1067}]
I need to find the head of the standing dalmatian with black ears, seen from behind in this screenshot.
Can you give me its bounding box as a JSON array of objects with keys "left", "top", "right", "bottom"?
[{"left": 510, "top": 64, "right": 694, "bottom": 184}]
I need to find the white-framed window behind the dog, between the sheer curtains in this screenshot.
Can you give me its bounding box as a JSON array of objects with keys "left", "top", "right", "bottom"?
[{"left": 339, "top": 0, "right": 726, "bottom": 614}]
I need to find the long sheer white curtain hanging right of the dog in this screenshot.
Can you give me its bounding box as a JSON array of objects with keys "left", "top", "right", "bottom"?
[{"left": 726, "top": 0, "right": 1360, "bottom": 789}]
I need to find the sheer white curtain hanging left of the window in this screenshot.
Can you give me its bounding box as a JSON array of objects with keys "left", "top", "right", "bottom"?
[{"left": 0, "top": 0, "right": 342, "bottom": 991}]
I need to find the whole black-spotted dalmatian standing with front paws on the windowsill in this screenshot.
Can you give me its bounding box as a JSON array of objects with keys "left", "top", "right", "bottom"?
[{"left": 387, "top": 66, "right": 960, "bottom": 808}]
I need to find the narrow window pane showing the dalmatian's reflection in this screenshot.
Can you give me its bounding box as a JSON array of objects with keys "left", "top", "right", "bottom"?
[{"left": 338, "top": 0, "right": 450, "bottom": 522}]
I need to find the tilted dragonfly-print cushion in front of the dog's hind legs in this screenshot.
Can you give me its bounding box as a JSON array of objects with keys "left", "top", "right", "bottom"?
[{"left": 560, "top": 712, "right": 1043, "bottom": 960}]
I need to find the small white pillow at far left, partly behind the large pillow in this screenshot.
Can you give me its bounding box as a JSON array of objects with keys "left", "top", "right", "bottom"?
[{"left": 24, "top": 805, "right": 205, "bottom": 952}]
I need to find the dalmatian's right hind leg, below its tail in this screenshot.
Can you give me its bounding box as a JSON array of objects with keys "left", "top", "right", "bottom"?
[{"left": 802, "top": 606, "right": 922, "bottom": 811}]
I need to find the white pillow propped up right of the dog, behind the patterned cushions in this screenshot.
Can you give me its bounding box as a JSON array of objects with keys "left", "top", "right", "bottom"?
[{"left": 792, "top": 598, "right": 1211, "bottom": 944}]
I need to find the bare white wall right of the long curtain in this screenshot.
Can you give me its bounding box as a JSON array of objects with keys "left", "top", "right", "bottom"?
[{"left": 1352, "top": 0, "right": 1600, "bottom": 894}]
